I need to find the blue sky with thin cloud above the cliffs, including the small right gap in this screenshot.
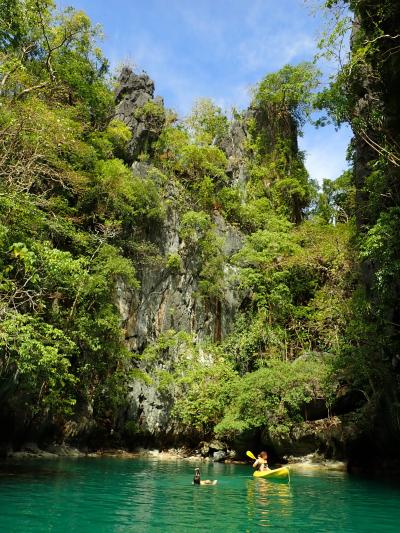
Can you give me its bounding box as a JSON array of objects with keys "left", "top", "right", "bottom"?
[{"left": 59, "top": 0, "right": 350, "bottom": 181}]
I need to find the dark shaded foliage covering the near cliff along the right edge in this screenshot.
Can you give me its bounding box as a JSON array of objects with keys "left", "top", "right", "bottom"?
[{"left": 318, "top": 0, "right": 400, "bottom": 446}]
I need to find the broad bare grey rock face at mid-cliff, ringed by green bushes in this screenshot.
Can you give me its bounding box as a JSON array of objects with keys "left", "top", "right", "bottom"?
[{"left": 117, "top": 177, "right": 242, "bottom": 352}]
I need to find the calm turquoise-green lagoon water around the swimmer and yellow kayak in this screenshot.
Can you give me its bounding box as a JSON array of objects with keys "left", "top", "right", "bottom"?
[{"left": 0, "top": 458, "right": 400, "bottom": 533}]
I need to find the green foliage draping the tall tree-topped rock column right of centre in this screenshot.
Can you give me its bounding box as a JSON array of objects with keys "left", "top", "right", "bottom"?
[{"left": 247, "top": 63, "right": 319, "bottom": 223}]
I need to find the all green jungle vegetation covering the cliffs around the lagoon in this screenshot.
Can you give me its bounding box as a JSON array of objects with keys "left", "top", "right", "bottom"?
[{"left": 0, "top": 0, "right": 400, "bottom": 458}]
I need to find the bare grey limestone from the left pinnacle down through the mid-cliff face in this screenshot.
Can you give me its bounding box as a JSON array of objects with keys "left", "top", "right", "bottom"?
[{"left": 116, "top": 69, "right": 242, "bottom": 352}]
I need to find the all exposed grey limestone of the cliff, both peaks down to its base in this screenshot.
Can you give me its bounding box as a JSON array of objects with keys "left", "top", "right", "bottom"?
[{"left": 111, "top": 69, "right": 338, "bottom": 450}]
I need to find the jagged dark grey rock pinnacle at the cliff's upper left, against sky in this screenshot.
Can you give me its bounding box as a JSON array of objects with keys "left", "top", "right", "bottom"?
[{"left": 115, "top": 67, "right": 165, "bottom": 162}]
